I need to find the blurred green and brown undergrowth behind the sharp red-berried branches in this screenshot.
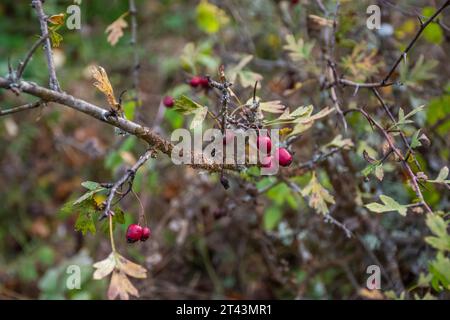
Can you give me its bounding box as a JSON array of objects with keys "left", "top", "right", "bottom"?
[{"left": 0, "top": 0, "right": 450, "bottom": 299}]
